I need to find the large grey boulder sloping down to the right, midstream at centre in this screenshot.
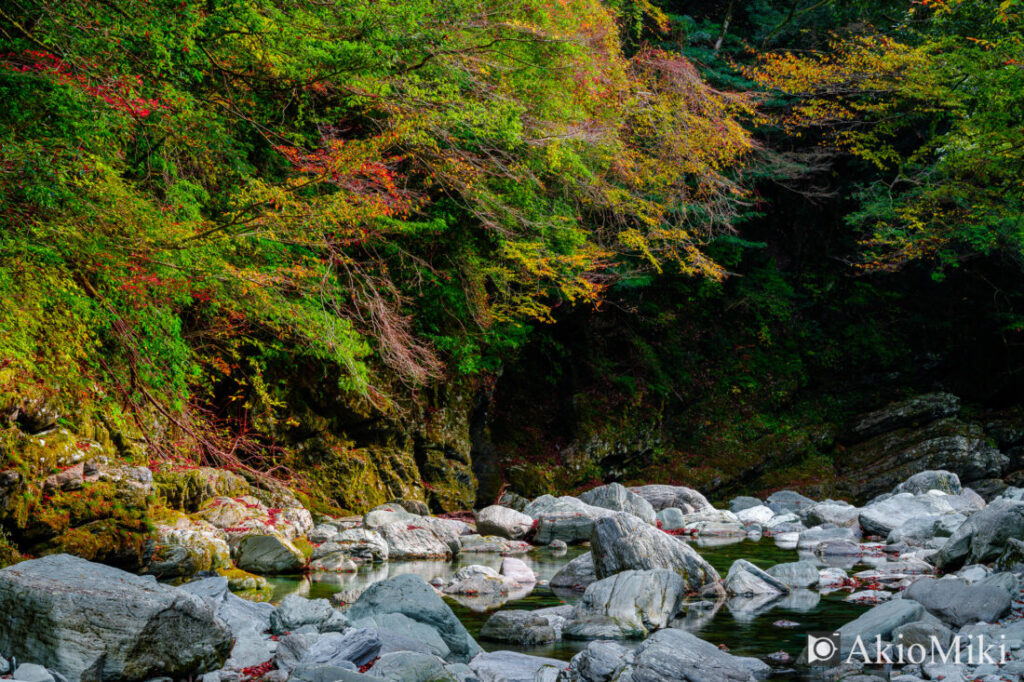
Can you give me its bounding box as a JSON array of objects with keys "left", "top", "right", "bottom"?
[{"left": 591, "top": 513, "right": 719, "bottom": 590}]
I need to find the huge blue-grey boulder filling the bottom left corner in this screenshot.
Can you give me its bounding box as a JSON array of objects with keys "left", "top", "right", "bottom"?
[{"left": 0, "top": 554, "right": 231, "bottom": 682}]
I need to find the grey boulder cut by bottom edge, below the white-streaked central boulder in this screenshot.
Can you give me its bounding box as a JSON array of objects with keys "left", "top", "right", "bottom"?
[{"left": 612, "top": 628, "right": 769, "bottom": 682}]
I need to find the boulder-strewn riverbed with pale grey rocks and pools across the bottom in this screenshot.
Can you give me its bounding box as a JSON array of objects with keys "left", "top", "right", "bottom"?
[{"left": 0, "top": 471, "right": 1024, "bottom": 682}]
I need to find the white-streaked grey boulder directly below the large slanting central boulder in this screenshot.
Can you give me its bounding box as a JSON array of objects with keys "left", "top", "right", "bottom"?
[{"left": 562, "top": 568, "right": 686, "bottom": 639}]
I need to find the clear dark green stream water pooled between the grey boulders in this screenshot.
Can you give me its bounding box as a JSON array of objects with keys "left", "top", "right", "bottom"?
[{"left": 269, "top": 539, "right": 878, "bottom": 667}]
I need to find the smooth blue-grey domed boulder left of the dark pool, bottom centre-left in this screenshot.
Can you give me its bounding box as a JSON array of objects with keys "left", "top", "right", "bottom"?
[{"left": 347, "top": 573, "right": 481, "bottom": 663}]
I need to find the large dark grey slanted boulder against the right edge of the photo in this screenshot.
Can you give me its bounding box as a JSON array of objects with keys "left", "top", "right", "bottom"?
[{"left": 930, "top": 498, "right": 1024, "bottom": 570}]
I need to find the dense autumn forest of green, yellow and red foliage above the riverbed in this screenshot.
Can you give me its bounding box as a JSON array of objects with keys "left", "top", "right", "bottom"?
[{"left": 0, "top": 0, "right": 1024, "bottom": 561}]
